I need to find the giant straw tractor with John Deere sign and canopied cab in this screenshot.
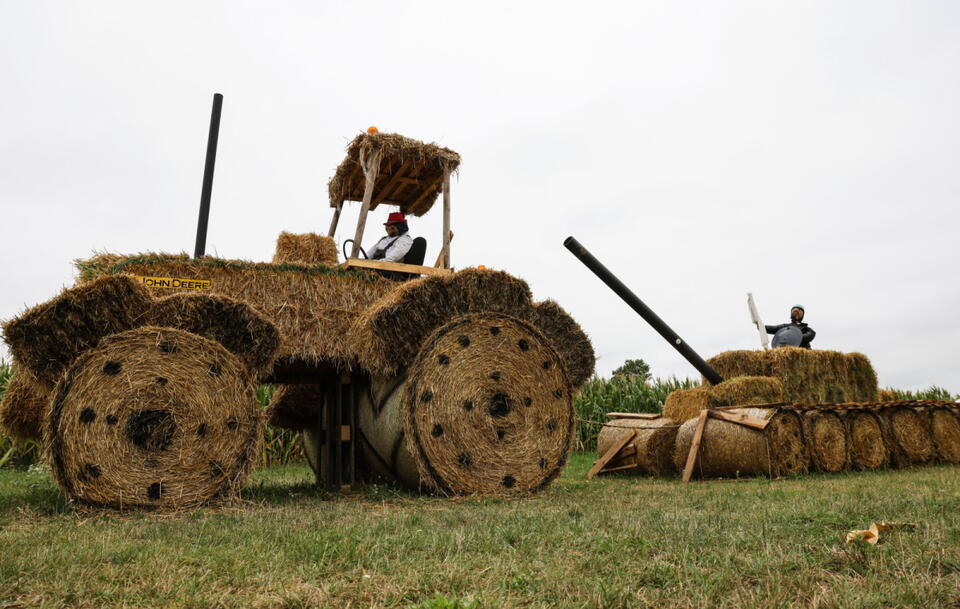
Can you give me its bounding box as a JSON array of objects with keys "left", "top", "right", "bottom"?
[{"left": 0, "top": 133, "right": 594, "bottom": 509}]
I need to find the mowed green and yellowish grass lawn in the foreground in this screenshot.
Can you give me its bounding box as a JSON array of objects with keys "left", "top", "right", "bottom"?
[{"left": 0, "top": 455, "right": 960, "bottom": 609}]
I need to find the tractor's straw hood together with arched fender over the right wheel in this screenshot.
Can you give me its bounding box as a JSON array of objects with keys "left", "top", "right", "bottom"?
[{"left": 76, "top": 253, "right": 595, "bottom": 388}]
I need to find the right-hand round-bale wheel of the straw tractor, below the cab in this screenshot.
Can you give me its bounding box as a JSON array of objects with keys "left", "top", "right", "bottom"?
[{"left": 359, "top": 313, "right": 574, "bottom": 495}]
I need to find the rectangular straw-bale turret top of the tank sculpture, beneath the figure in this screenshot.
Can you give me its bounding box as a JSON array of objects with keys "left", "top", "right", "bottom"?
[{"left": 704, "top": 347, "right": 877, "bottom": 404}]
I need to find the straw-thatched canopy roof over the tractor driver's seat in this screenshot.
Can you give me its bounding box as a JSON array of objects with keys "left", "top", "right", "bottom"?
[{"left": 328, "top": 133, "right": 460, "bottom": 216}]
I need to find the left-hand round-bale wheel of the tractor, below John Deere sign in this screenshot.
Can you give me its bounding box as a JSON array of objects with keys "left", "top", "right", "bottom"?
[{"left": 45, "top": 327, "right": 262, "bottom": 510}]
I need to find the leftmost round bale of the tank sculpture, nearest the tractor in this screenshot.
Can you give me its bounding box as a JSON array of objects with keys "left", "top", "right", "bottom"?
[{"left": 597, "top": 417, "right": 680, "bottom": 476}]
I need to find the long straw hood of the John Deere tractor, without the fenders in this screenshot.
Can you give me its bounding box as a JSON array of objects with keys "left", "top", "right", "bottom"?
[{"left": 78, "top": 254, "right": 398, "bottom": 370}]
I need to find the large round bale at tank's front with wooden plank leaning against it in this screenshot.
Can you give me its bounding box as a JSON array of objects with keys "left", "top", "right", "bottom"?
[{"left": 674, "top": 407, "right": 809, "bottom": 478}]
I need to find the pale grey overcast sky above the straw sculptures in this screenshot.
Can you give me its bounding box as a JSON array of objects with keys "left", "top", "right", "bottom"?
[{"left": 0, "top": 0, "right": 960, "bottom": 392}]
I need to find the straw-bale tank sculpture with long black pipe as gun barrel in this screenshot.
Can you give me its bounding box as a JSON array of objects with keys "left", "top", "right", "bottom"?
[{"left": 565, "top": 237, "right": 960, "bottom": 480}]
